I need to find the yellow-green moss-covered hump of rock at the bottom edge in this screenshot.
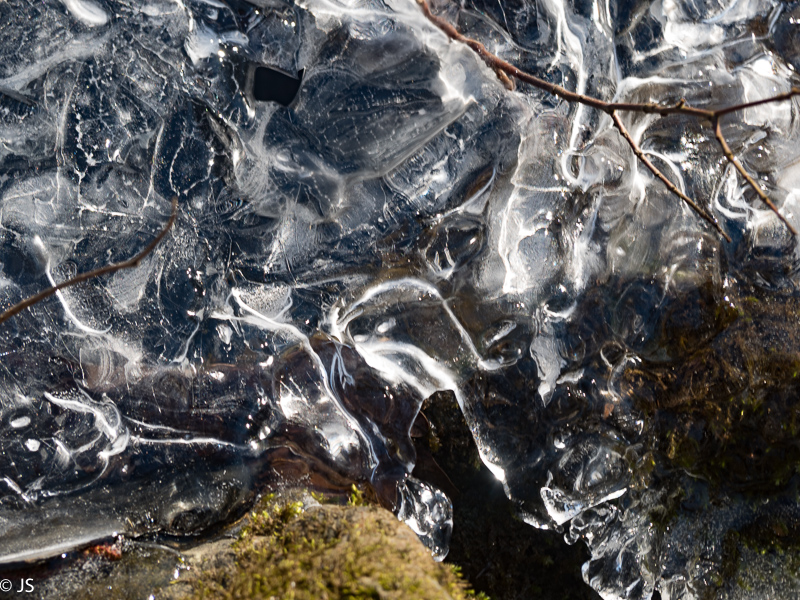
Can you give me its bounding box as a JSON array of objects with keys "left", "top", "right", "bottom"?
[{"left": 156, "top": 497, "right": 474, "bottom": 600}]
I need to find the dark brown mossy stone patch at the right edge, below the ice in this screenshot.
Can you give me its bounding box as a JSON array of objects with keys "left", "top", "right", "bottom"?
[{"left": 621, "top": 290, "right": 800, "bottom": 493}]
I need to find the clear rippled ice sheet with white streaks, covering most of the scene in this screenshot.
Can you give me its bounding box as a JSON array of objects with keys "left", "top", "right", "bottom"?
[{"left": 0, "top": 0, "right": 800, "bottom": 599}]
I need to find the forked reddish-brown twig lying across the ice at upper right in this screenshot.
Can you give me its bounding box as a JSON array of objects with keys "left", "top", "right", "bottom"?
[{"left": 417, "top": 0, "right": 800, "bottom": 241}]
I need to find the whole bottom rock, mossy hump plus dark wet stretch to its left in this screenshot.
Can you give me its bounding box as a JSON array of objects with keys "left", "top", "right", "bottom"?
[{"left": 3, "top": 490, "right": 476, "bottom": 600}]
